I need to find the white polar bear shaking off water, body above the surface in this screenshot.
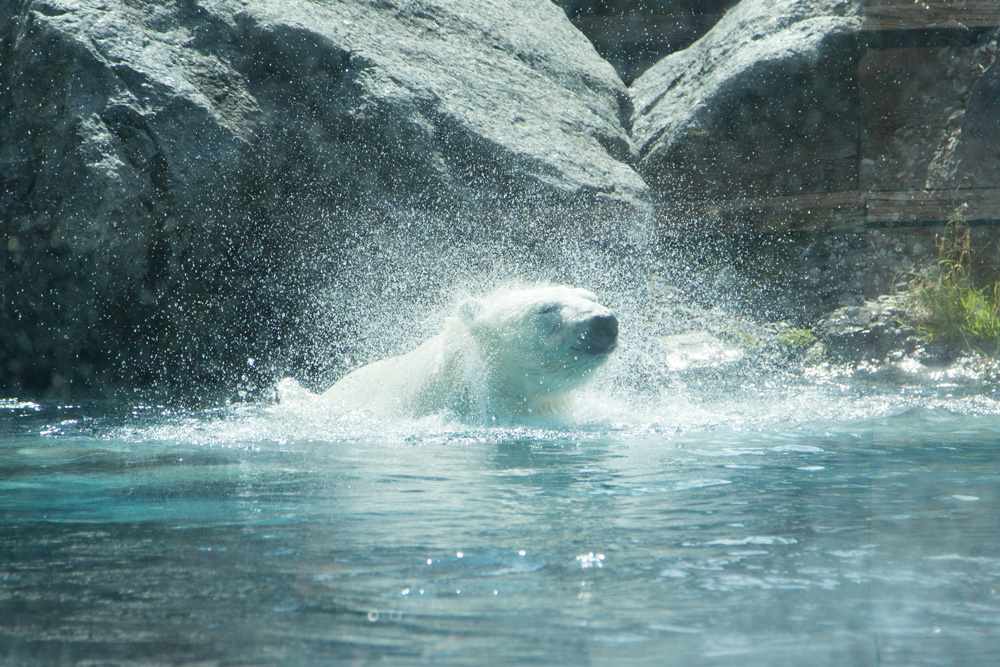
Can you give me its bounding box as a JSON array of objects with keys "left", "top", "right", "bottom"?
[{"left": 321, "top": 286, "right": 618, "bottom": 420}]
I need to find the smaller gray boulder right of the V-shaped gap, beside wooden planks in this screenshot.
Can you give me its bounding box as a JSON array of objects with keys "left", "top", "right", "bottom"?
[{"left": 630, "top": 0, "right": 861, "bottom": 204}]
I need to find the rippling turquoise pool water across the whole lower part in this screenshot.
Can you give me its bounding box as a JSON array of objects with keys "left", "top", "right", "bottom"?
[{"left": 0, "top": 377, "right": 1000, "bottom": 666}]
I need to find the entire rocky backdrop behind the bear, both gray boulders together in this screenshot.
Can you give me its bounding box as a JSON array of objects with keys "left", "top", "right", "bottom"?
[{"left": 0, "top": 0, "right": 1000, "bottom": 393}]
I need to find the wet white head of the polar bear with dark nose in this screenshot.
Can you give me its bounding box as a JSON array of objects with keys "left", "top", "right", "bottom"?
[{"left": 458, "top": 287, "right": 618, "bottom": 400}]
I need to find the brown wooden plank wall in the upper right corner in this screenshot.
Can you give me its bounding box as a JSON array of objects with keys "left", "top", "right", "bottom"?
[{"left": 858, "top": 0, "right": 1000, "bottom": 228}]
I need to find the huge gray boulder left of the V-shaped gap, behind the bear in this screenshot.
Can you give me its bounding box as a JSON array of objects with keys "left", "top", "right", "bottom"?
[{"left": 0, "top": 0, "right": 648, "bottom": 391}]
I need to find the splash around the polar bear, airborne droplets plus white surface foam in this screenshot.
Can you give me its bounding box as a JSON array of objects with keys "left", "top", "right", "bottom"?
[{"left": 58, "top": 206, "right": 996, "bottom": 442}]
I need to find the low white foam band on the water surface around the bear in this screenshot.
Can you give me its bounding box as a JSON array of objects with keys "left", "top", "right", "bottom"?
[{"left": 97, "top": 340, "right": 1000, "bottom": 454}]
